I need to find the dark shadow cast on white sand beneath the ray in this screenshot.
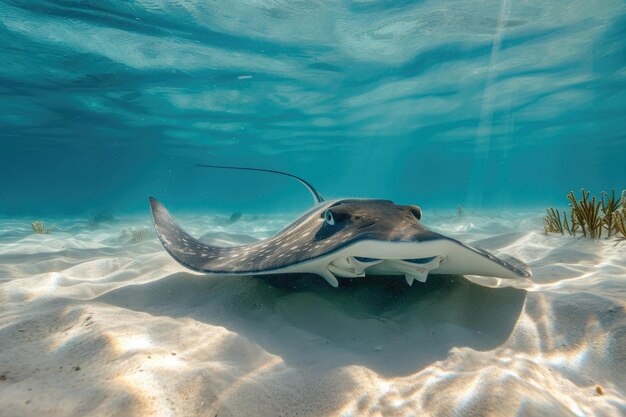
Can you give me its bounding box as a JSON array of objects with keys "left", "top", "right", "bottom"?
[{"left": 96, "top": 272, "right": 526, "bottom": 376}]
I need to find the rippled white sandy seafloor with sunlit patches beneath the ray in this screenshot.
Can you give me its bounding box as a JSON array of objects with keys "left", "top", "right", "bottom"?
[{"left": 0, "top": 211, "right": 626, "bottom": 417}]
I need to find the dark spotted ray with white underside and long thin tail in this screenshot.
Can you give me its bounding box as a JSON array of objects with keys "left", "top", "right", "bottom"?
[{"left": 150, "top": 165, "right": 531, "bottom": 287}]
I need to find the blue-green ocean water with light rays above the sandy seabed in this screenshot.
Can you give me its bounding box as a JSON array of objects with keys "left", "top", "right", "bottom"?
[{"left": 0, "top": 0, "right": 626, "bottom": 216}]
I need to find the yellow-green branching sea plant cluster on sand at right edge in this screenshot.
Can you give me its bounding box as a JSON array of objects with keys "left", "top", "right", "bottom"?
[{"left": 544, "top": 188, "right": 626, "bottom": 239}]
